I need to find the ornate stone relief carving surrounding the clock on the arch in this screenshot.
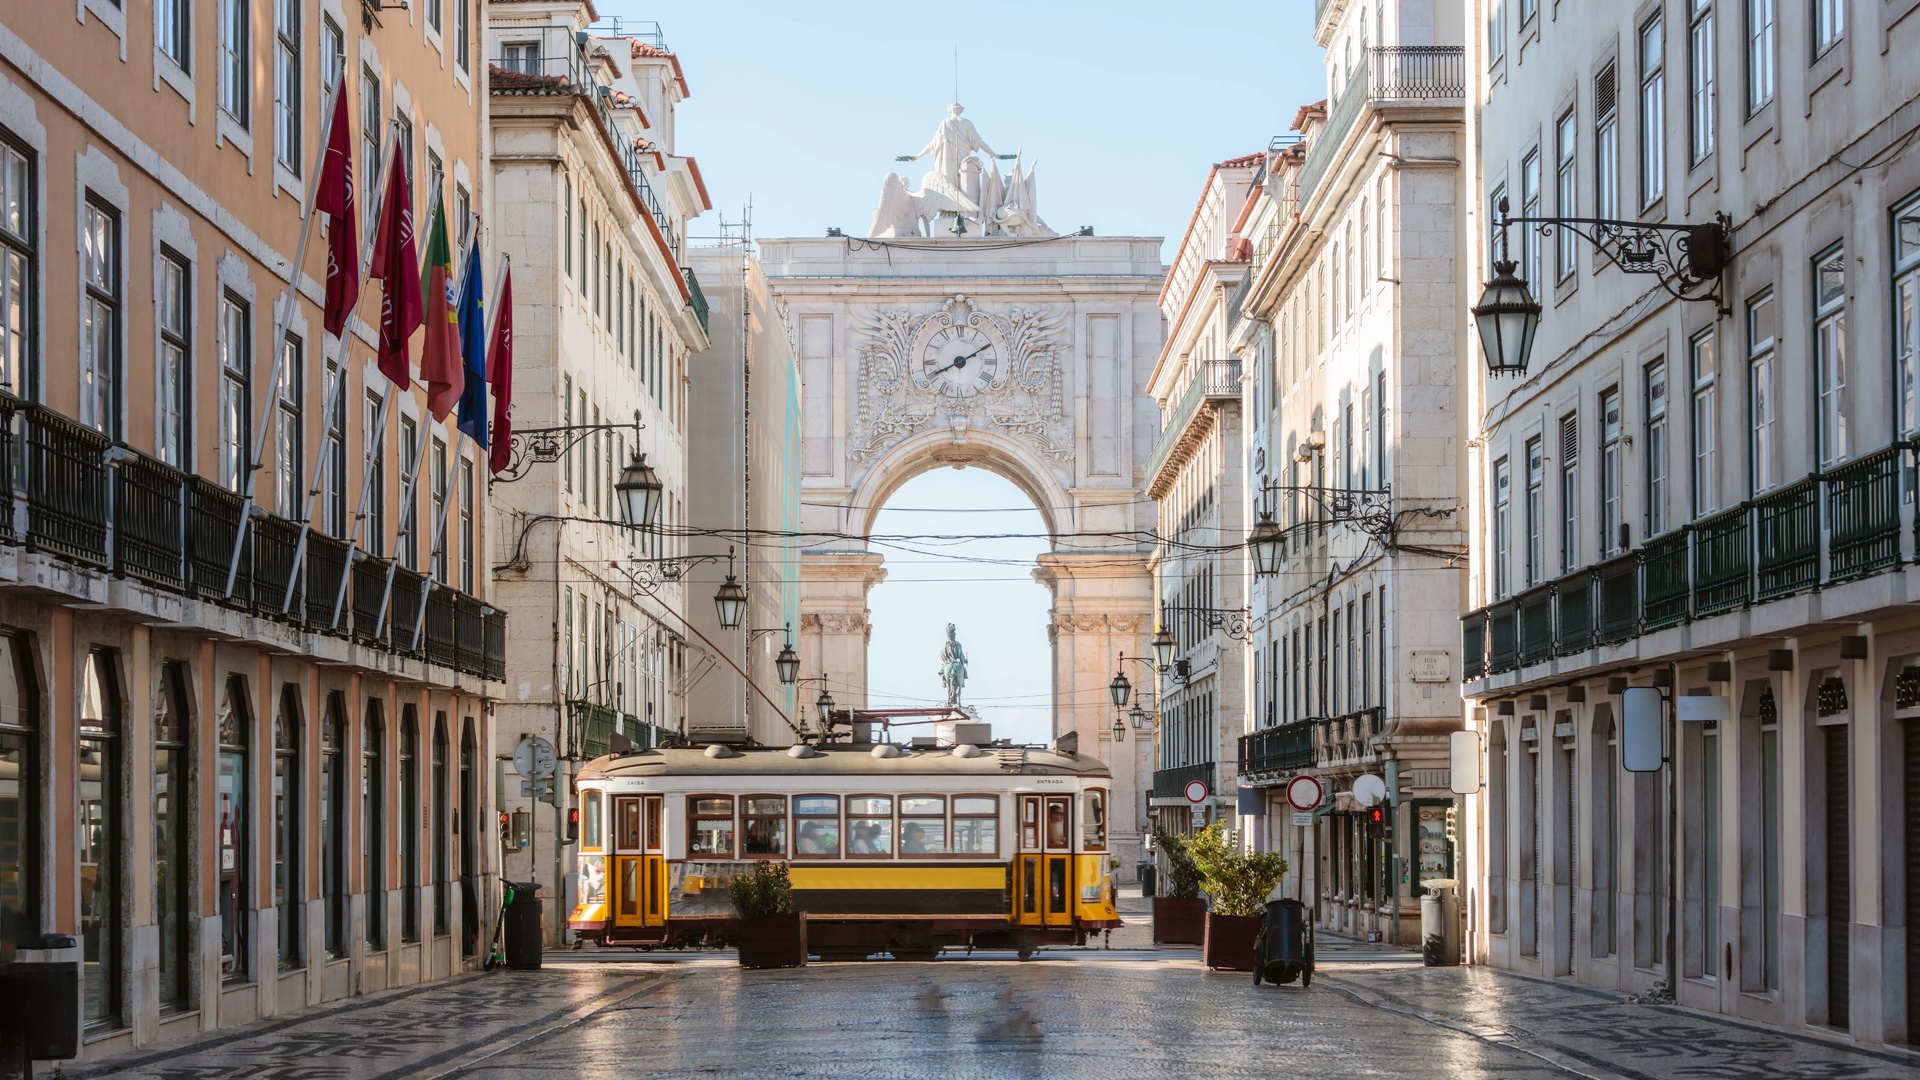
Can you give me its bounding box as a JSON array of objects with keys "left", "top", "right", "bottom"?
[{"left": 847, "top": 294, "right": 1073, "bottom": 469}]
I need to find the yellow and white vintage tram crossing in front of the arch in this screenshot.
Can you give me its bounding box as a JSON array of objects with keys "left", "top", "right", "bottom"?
[{"left": 566, "top": 744, "right": 1119, "bottom": 959}]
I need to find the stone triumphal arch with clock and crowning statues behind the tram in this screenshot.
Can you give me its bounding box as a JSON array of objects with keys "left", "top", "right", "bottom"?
[{"left": 758, "top": 111, "right": 1164, "bottom": 859}]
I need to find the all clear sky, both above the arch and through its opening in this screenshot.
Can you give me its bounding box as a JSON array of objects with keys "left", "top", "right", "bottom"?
[{"left": 597, "top": 0, "right": 1325, "bottom": 742}]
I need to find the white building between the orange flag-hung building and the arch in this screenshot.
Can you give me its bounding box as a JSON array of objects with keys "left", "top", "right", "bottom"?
[{"left": 488, "top": 0, "right": 710, "bottom": 928}]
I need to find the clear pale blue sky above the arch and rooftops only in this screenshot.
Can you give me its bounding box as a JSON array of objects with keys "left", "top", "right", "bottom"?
[{"left": 597, "top": 0, "right": 1327, "bottom": 258}]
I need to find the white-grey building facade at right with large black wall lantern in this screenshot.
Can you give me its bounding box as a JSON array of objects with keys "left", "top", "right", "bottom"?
[{"left": 1457, "top": 0, "right": 1920, "bottom": 1043}]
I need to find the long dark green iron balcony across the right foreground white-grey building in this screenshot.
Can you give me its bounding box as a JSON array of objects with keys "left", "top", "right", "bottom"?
[{"left": 1461, "top": 442, "right": 1920, "bottom": 682}]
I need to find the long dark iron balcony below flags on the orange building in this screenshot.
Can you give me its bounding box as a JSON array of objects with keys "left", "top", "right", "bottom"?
[{"left": 0, "top": 394, "right": 507, "bottom": 678}]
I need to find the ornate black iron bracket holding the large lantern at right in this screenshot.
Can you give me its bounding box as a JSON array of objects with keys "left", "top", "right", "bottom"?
[{"left": 1500, "top": 208, "right": 1734, "bottom": 315}]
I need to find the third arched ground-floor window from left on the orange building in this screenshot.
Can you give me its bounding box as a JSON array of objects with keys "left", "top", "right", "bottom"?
[{"left": 154, "top": 661, "right": 198, "bottom": 1015}]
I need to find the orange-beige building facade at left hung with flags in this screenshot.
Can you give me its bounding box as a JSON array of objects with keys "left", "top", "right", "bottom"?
[{"left": 0, "top": 0, "right": 505, "bottom": 1061}]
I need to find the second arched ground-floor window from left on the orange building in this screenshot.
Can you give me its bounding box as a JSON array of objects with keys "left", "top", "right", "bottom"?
[{"left": 77, "top": 650, "right": 127, "bottom": 1028}]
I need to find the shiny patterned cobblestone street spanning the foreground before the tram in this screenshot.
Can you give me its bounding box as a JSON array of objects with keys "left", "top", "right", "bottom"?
[{"left": 63, "top": 895, "right": 1920, "bottom": 1080}]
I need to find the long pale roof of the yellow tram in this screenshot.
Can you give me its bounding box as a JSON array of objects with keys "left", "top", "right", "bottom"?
[{"left": 578, "top": 744, "right": 1112, "bottom": 780}]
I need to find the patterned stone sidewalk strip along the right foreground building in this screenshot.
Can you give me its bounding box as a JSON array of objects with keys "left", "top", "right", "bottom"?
[{"left": 1313, "top": 949, "right": 1920, "bottom": 1080}]
